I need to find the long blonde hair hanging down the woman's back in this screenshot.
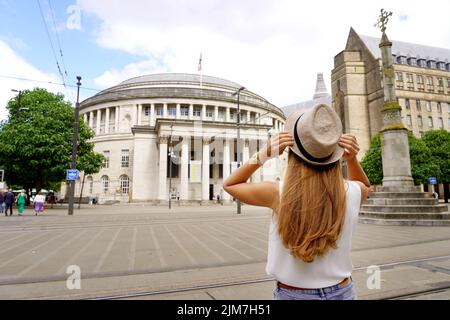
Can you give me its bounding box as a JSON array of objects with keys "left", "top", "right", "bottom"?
[{"left": 275, "top": 152, "right": 346, "bottom": 262}]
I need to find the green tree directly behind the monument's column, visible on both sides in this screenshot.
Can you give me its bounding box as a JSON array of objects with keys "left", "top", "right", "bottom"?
[{"left": 361, "top": 132, "right": 439, "bottom": 185}]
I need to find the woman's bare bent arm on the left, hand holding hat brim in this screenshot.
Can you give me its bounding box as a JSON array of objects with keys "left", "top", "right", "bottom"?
[{"left": 223, "top": 132, "right": 294, "bottom": 209}]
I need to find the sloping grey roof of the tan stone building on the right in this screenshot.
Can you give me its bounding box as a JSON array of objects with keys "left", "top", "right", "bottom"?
[{"left": 359, "top": 35, "right": 450, "bottom": 62}]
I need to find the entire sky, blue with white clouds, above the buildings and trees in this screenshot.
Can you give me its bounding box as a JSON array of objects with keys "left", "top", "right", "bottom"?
[{"left": 0, "top": 0, "right": 450, "bottom": 119}]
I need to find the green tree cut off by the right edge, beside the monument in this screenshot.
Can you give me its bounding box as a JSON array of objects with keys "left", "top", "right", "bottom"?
[{"left": 422, "top": 130, "right": 450, "bottom": 183}]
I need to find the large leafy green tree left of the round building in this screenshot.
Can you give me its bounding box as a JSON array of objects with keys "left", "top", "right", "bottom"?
[{"left": 0, "top": 88, "right": 103, "bottom": 191}]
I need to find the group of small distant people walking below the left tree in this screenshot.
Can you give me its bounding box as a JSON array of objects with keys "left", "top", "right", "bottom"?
[{"left": 0, "top": 189, "right": 45, "bottom": 217}]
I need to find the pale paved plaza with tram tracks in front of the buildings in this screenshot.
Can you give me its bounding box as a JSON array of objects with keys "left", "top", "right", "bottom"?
[{"left": 0, "top": 204, "right": 450, "bottom": 299}]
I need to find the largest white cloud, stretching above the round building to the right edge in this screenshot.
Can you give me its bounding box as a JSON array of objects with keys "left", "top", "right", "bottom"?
[{"left": 79, "top": 0, "right": 450, "bottom": 106}]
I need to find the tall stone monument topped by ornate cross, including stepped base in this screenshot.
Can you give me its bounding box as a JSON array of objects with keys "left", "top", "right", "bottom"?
[{"left": 360, "top": 9, "right": 450, "bottom": 225}]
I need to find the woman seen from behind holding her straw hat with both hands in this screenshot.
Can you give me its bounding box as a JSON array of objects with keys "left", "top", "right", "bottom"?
[{"left": 224, "top": 104, "right": 370, "bottom": 300}]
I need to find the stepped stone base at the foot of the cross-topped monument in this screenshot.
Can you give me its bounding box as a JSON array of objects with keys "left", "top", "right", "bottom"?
[{"left": 359, "top": 186, "right": 450, "bottom": 226}]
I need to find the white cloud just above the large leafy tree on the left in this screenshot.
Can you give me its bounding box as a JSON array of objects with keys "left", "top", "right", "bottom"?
[{"left": 0, "top": 40, "right": 73, "bottom": 120}]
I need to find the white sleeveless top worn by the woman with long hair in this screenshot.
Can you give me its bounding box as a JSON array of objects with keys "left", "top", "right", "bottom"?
[{"left": 266, "top": 181, "right": 361, "bottom": 289}]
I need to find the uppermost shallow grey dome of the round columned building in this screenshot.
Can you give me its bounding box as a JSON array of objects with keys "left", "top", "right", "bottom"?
[{"left": 119, "top": 73, "right": 242, "bottom": 89}]
